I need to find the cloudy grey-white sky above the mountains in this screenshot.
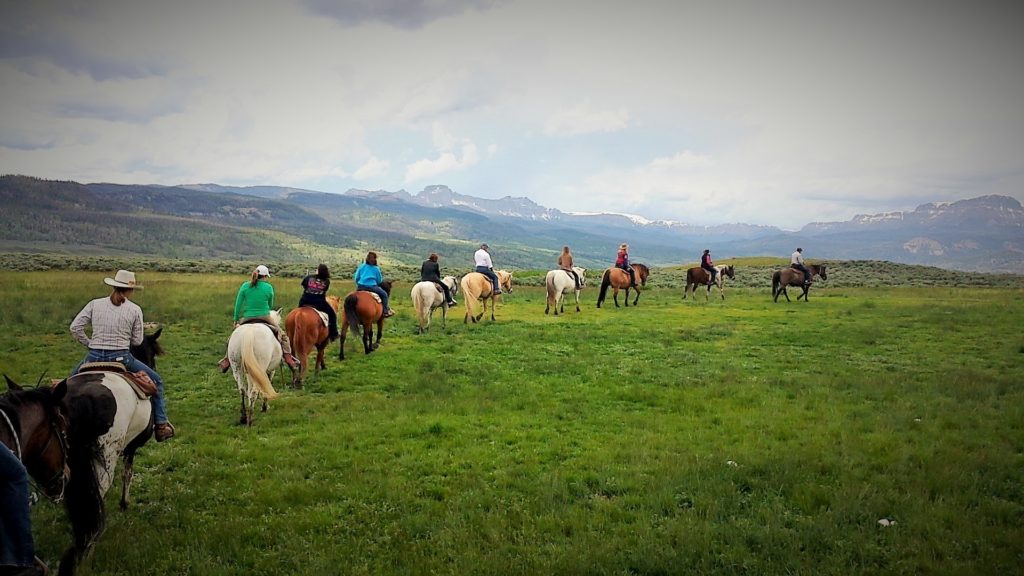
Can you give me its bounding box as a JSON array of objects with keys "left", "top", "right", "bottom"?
[{"left": 0, "top": 0, "right": 1024, "bottom": 230}]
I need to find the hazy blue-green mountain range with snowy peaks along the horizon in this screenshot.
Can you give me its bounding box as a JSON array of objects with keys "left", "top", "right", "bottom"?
[{"left": 0, "top": 175, "right": 1024, "bottom": 274}]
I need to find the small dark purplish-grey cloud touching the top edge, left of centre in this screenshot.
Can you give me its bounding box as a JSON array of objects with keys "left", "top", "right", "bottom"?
[{"left": 303, "top": 0, "right": 495, "bottom": 30}]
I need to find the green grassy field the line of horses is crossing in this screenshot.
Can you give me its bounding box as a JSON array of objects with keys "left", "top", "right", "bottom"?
[{"left": 0, "top": 270, "right": 1024, "bottom": 575}]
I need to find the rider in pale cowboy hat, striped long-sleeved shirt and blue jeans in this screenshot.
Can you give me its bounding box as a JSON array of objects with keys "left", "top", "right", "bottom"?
[{"left": 71, "top": 270, "right": 174, "bottom": 442}]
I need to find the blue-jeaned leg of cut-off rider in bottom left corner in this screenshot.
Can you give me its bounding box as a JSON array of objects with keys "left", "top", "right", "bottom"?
[{"left": 0, "top": 444, "right": 36, "bottom": 567}]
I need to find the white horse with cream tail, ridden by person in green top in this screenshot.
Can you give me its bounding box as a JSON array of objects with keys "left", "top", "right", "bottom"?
[{"left": 227, "top": 310, "right": 281, "bottom": 426}]
